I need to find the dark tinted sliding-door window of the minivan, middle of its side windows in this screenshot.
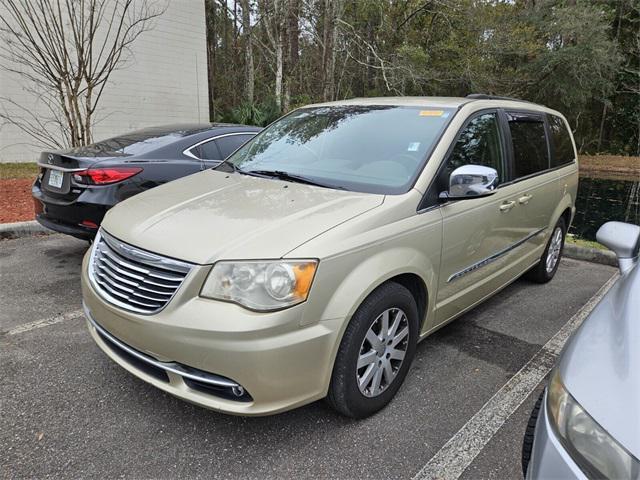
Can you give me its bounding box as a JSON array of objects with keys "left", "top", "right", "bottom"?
[{"left": 509, "top": 115, "right": 549, "bottom": 179}]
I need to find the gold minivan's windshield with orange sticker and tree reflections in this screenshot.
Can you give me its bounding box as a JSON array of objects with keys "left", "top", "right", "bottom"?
[{"left": 222, "top": 105, "right": 454, "bottom": 194}]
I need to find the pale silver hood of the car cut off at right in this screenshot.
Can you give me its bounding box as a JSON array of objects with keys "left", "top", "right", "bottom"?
[{"left": 560, "top": 265, "right": 640, "bottom": 458}]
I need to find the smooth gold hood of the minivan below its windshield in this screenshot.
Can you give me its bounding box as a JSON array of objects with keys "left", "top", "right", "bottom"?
[{"left": 102, "top": 170, "right": 384, "bottom": 264}]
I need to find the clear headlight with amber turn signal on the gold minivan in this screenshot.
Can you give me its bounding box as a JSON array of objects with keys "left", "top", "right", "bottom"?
[{"left": 200, "top": 260, "right": 318, "bottom": 311}]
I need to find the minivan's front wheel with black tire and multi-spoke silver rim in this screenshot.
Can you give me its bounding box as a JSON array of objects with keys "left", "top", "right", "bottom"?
[{"left": 326, "top": 282, "right": 419, "bottom": 418}]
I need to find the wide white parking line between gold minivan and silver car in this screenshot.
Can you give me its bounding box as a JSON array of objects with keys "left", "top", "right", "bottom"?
[{"left": 413, "top": 273, "right": 619, "bottom": 480}]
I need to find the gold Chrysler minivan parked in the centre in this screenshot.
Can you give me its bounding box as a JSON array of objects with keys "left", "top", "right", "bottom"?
[{"left": 82, "top": 95, "right": 578, "bottom": 418}]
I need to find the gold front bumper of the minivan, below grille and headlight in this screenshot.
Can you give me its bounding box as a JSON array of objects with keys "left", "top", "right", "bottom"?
[{"left": 82, "top": 251, "right": 341, "bottom": 415}]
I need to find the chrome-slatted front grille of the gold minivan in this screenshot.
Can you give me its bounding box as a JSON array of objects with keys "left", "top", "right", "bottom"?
[{"left": 89, "top": 230, "right": 193, "bottom": 314}]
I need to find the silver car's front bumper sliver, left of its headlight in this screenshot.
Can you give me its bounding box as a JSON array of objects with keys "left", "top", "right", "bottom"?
[{"left": 527, "top": 393, "right": 587, "bottom": 480}]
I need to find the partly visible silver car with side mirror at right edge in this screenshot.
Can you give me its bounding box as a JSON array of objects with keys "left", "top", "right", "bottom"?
[{"left": 523, "top": 222, "right": 640, "bottom": 479}]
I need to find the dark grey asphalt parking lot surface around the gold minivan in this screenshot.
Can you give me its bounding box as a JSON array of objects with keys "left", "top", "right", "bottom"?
[{"left": 0, "top": 235, "right": 615, "bottom": 479}]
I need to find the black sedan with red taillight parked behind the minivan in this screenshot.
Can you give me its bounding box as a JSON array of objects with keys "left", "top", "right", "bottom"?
[{"left": 32, "top": 124, "right": 261, "bottom": 240}]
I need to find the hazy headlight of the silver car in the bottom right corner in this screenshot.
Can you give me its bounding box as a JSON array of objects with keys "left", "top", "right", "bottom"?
[{"left": 547, "top": 369, "right": 640, "bottom": 479}]
